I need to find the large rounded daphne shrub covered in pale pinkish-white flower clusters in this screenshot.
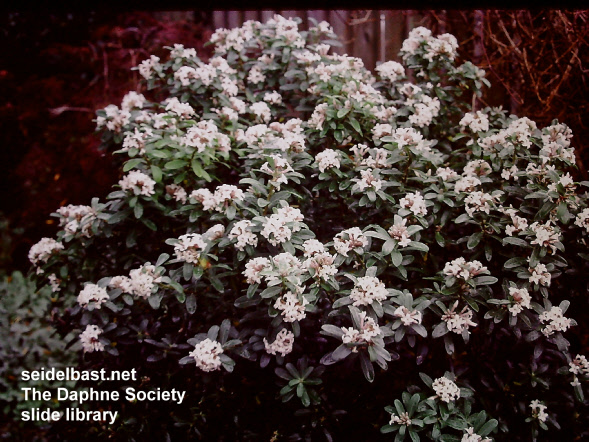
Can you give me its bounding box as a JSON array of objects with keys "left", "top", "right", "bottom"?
[{"left": 30, "top": 16, "right": 589, "bottom": 441}]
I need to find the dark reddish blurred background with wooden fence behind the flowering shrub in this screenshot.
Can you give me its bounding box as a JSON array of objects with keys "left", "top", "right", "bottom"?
[{"left": 0, "top": 10, "right": 589, "bottom": 274}]
